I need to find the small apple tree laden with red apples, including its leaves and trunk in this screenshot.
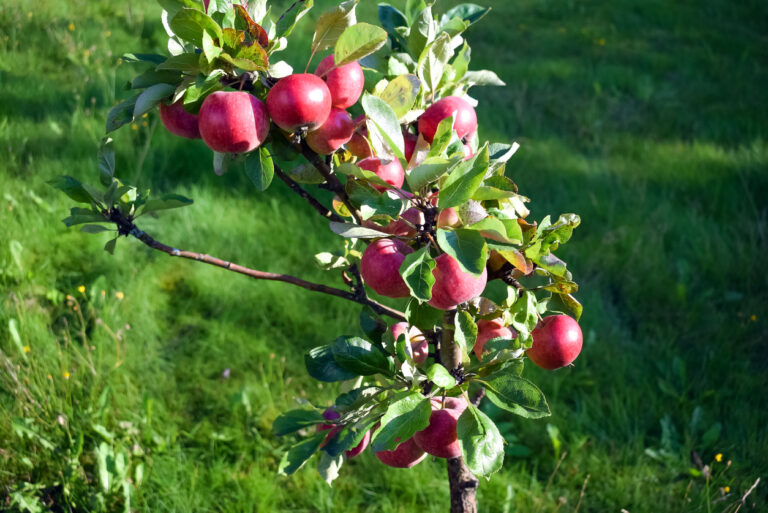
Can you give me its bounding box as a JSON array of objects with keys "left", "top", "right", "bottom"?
[{"left": 52, "top": 0, "right": 582, "bottom": 512}]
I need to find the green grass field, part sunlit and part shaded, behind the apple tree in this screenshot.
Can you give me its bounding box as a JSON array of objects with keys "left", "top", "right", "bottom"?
[{"left": 0, "top": 0, "right": 768, "bottom": 513}]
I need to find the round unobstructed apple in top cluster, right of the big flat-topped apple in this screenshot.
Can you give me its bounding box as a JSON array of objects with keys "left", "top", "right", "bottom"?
[{"left": 267, "top": 73, "right": 331, "bottom": 133}]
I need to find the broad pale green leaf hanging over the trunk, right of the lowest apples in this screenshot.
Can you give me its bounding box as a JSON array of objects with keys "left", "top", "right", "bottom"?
[{"left": 456, "top": 404, "right": 504, "bottom": 476}]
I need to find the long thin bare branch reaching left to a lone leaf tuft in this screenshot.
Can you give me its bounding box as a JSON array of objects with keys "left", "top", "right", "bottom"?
[{"left": 108, "top": 209, "right": 406, "bottom": 321}]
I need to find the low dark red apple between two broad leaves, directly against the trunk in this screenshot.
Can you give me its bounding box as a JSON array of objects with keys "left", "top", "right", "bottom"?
[{"left": 413, "top": 397, "right": 467, "bottom": 458}]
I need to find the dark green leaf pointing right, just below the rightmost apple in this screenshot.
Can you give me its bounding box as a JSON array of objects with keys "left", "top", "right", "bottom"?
[{"left": 483, "top": 372, "right": 551, "bottom": 419}]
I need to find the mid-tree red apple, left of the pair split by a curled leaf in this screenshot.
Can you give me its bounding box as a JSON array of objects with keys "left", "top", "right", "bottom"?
[{"left": 360, "top": 239, "right": 413, "bottom": 297}]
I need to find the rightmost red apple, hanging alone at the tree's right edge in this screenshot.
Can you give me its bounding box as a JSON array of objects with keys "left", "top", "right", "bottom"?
[{"left": 525, "top": 314, "right": 583, "bottom": 370}]
